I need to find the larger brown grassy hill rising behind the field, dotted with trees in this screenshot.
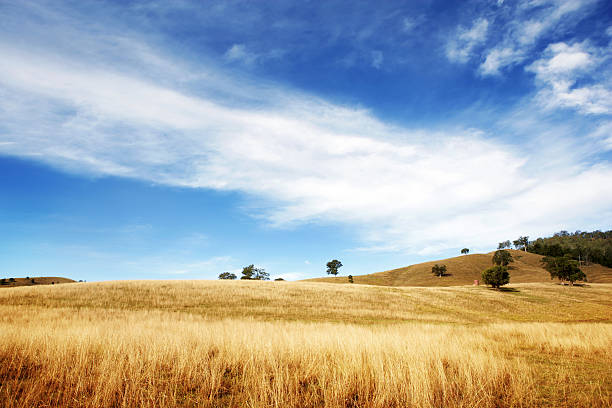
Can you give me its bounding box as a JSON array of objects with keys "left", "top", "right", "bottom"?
[{"left": 307, "top": 250, "right": 612, "bottom": 286}]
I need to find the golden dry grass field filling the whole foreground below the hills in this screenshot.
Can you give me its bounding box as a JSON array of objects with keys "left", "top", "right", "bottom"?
[{"left": 0, "top": 281, "right": 612, "bottom": 408}]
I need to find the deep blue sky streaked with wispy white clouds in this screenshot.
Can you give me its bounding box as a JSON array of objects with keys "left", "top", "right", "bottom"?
[{"left": 0, "top": 0, "right": 612, "bottom": 280}]
